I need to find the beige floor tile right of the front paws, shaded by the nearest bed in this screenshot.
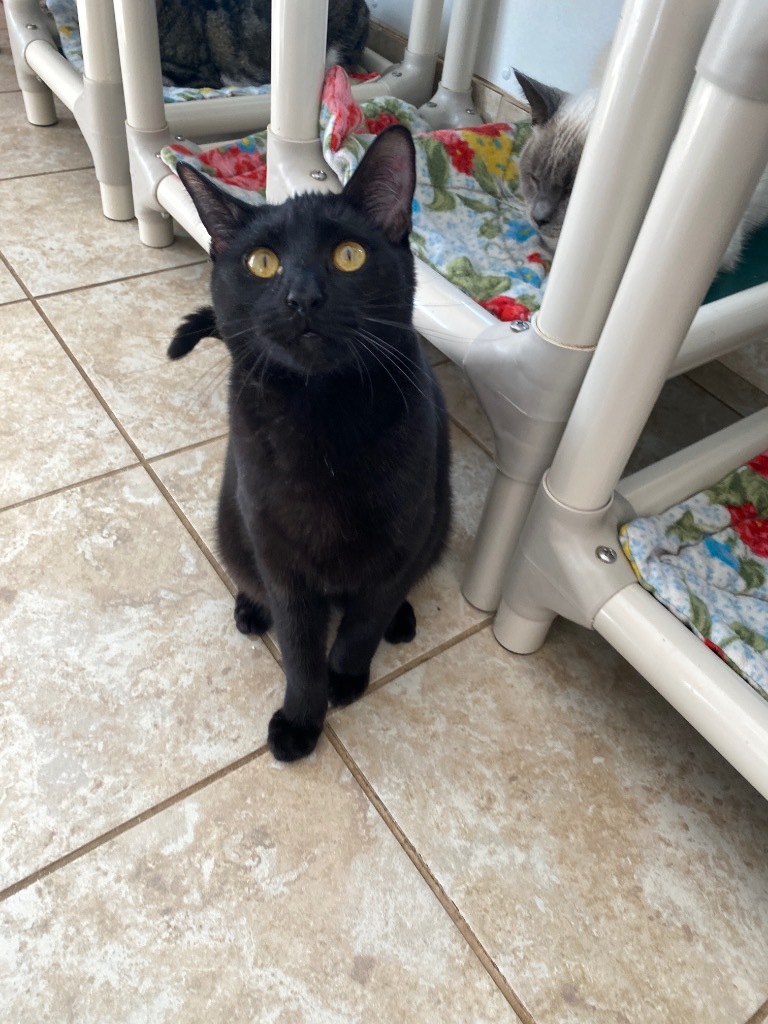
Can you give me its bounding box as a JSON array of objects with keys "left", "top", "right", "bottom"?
[{"left": 334, "top": 624, "right": 768, "bottom": 1024}]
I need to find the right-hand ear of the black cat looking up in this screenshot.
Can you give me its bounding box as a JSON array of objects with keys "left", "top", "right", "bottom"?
[{"left": 344, "top": 125, "right": 416, "bottom": 243}]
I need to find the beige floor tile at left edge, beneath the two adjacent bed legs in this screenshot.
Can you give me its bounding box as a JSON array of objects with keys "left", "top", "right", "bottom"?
[{"left": 0, "top": 169, "right": 204, "bottom": 294}]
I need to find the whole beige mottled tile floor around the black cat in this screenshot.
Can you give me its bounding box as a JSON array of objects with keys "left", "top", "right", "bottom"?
[{"left": 0, "top": 22, "right": 768, "bottom": 1024}]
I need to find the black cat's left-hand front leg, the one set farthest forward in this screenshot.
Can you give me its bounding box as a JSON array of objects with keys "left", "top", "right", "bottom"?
[{"left": 267, "top": 591, "right": 330, "bottom": 761}]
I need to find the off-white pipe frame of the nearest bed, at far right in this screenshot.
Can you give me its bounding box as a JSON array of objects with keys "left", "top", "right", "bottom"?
[{"left": 495, "top": 0, "right": 768, "bottom": 798}]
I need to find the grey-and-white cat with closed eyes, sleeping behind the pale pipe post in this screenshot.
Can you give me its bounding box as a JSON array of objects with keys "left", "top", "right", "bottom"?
[{"left": 515, "top": 71, "right": 768, "bottom": 270}]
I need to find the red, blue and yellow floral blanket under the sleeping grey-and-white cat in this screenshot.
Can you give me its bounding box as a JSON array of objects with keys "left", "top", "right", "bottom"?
[{"left": 162, "top": 68, "right": 550, "bottom": 321}]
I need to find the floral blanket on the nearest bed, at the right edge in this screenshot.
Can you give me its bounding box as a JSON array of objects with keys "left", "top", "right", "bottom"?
[{"left": 621, "top": 452, "right": 768, "bottom": 699}]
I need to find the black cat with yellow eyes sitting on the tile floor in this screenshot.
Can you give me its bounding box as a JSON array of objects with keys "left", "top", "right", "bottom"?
[{"left": 168, "top": 126, "right": 451, "bottom": 761}]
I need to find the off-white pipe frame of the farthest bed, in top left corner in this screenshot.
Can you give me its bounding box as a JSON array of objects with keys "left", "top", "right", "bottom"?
[{"left": 3, "top": 0, "right": 133, "bottom": 220}]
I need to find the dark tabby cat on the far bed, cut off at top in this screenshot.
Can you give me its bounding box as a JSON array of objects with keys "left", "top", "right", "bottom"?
[{"left": 156, "top": 0, "right": 369, "bottom": 88}]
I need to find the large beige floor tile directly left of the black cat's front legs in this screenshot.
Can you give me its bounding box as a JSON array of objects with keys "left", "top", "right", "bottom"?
[{"left": 0, "top": 468, "right": 283, "bottom": 888}]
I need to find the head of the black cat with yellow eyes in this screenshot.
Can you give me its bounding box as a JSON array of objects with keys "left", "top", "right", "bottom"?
[{"left": 178, "top": 126, "right": 416, "bottom": 376}]
